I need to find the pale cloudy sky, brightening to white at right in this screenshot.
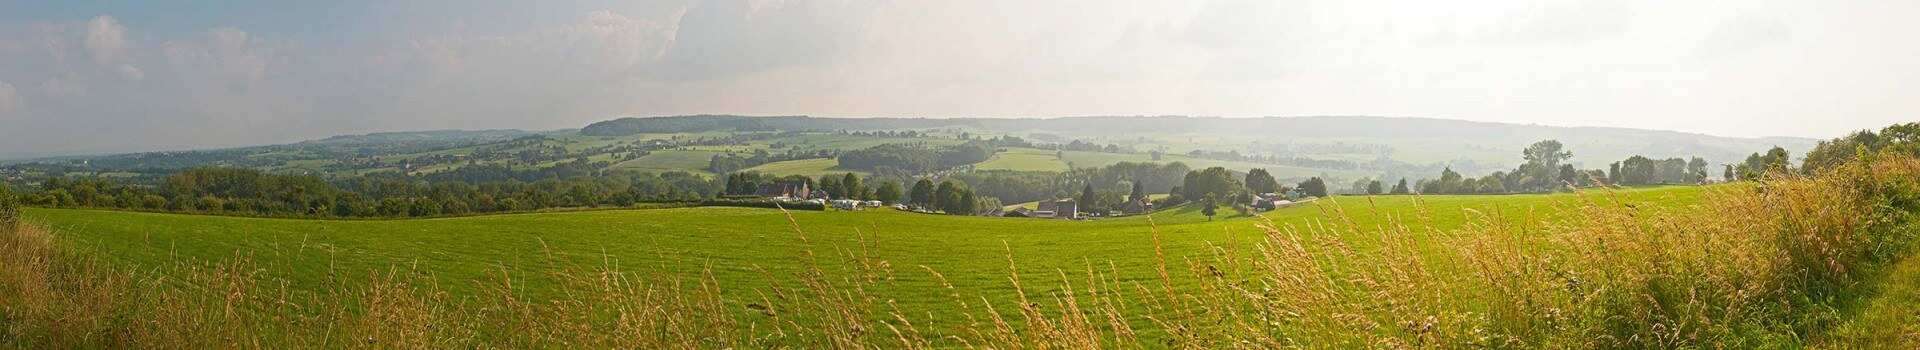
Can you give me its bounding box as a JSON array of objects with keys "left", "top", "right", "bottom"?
[{"left": 0, "top": 0, "right": 1920, "bottom": 158}]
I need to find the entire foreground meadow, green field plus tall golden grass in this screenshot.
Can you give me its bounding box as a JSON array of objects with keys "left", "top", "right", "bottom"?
[{"left": 0, "top": 160, "right": 1920, "bottom": 348}]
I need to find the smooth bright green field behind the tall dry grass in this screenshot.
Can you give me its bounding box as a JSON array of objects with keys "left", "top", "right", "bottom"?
[{"left": 27, "top": 187, "right": 1705, "bottom": 332}]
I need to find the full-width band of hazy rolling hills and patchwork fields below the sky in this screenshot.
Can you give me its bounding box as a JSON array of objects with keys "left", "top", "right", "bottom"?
[{"left": 0, "top": 115, "right": 1814, "bottom": 181}]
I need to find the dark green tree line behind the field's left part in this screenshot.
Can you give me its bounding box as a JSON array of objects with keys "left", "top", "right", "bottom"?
[{"left": 23, "top": 167, "right": 718, "bottom": 217}]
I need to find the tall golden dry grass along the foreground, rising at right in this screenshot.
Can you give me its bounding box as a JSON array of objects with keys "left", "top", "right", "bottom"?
[{"left": 11, "top": 158, "right": 1920, "bottom": 348}]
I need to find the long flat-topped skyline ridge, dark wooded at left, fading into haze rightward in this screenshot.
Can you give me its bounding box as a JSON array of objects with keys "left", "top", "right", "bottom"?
[{"left": 580, "top": 115, "right": 1816, "bottom": 167}]
